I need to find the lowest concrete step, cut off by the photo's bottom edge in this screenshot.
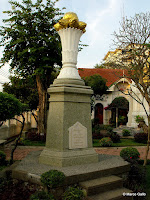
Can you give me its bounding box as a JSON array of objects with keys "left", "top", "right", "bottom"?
[{"left": 87, "top": 188, "right": 133, "bottom": 200}]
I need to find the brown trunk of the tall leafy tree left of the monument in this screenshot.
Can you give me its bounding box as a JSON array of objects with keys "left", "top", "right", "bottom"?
[{"left": 36, "top": 75, "right": 46, "bottom": 134}]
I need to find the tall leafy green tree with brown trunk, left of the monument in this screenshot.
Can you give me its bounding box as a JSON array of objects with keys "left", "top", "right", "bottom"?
[{"left": 0, "top": 0, "right": 62, "bottom": 133}]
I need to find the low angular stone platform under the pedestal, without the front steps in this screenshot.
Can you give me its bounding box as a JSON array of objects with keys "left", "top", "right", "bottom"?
[{"left": 12, "top": 151, "right": 130, "bottom": 184}]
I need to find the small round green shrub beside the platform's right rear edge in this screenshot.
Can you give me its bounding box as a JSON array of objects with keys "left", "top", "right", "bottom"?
[{"left": 120, "top": 147, "right": 140, "bottom": 162}]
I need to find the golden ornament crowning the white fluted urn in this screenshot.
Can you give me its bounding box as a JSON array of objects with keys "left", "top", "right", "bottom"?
[{"left": 54, "top": 12, "right": 87, "bottom": 33}]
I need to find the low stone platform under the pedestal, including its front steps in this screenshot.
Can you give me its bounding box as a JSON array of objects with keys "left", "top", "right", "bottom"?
[{"left": 9, "top": 151, "right": 132, "bottom": 200}]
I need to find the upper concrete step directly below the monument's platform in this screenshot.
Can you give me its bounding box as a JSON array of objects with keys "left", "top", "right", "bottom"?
[{"left": 79, "top": 175, "right": 123, "bottom": 195}]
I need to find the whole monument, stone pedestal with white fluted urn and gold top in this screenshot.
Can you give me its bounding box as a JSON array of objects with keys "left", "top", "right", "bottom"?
[{"left": 39, "top": 12, "right": 98, "bottom": 167}]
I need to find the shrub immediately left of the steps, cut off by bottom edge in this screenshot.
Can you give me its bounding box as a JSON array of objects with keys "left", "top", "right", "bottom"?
[{"left": 62, "top": 187, "right": 84, "bottom": 200}]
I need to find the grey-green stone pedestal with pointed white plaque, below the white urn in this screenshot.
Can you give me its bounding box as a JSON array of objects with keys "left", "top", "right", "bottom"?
[{"left": 39, "top": 79, "right": 98, "bottom": 167}]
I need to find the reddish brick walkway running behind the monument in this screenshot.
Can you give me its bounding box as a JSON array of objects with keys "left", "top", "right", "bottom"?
[{"left": 4, "top": 144, "right": 150, "bottom": 160}]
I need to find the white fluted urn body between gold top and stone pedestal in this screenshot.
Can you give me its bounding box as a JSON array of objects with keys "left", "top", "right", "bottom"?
[{"left": 57, "top": 27, "right": 83, "bottom": 79}]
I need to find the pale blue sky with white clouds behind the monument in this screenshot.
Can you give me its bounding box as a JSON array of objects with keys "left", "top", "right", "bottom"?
[{"left": 0, "top": 0, "right": 150, "bottom": 90}]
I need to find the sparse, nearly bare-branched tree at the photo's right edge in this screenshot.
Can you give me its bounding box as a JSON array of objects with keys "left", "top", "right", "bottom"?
[{"left": 105, "top": 12, "right": 150, "bottom": 165}]
